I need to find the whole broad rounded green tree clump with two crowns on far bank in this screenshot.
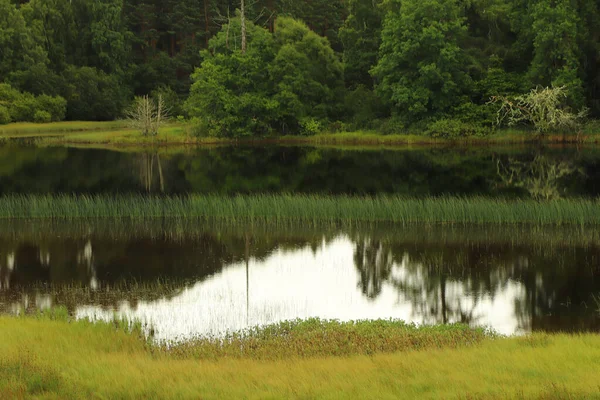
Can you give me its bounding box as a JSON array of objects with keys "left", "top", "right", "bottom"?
[{"left": 187, "top": 17, "right": 343, "bottom": 137}]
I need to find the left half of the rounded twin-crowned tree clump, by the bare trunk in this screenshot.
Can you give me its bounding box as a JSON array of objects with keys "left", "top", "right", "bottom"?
[{"left": 186, "top": 19, "right": 279, "bottom": 137}]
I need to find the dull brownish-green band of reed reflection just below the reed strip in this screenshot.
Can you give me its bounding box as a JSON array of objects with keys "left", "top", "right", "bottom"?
[{"left": 0, "top": 218, "right": 600, "bottom": 249}]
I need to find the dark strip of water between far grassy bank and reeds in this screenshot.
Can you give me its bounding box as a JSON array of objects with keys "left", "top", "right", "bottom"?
[{"left": 0, "top": 146, "right": 600, "bottom": 198}]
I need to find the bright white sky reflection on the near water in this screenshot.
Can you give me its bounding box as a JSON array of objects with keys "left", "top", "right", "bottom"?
[{"left": 76, "top": 236, "right": 525, "bottom": 341}]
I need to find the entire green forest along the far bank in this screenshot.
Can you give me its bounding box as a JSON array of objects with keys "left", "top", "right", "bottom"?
[{"left": 0, "top": 0, "right": 600, "bottom": 137}]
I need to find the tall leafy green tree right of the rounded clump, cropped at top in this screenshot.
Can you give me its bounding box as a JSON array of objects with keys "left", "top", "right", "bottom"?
[{"left": 372, "top": 0, "right": 472, "bottom": 123}]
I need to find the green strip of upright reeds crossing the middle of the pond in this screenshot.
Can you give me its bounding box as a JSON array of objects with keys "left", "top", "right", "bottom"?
[{"left": 0, "top": 195, "right": 600, "bottom": 225}]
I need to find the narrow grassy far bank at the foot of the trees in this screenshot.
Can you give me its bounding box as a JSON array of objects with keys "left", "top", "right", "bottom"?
[{"left": 0, "top": 121, "right": 600, "bottom": 147}]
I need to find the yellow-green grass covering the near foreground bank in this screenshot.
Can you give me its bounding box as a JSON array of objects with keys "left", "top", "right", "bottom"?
[{"left": 0, "top": 317, "right": 600, "bottom": 399}]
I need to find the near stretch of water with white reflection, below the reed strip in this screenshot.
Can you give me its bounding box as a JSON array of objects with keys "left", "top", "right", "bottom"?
[{"left": 0, "top": 221, "right": 600, "bottom": 340}]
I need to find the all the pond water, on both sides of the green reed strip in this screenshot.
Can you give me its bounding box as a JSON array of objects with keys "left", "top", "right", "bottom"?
[{"left": 0, "top": 146, "right": 600, "bottom": 340}]
